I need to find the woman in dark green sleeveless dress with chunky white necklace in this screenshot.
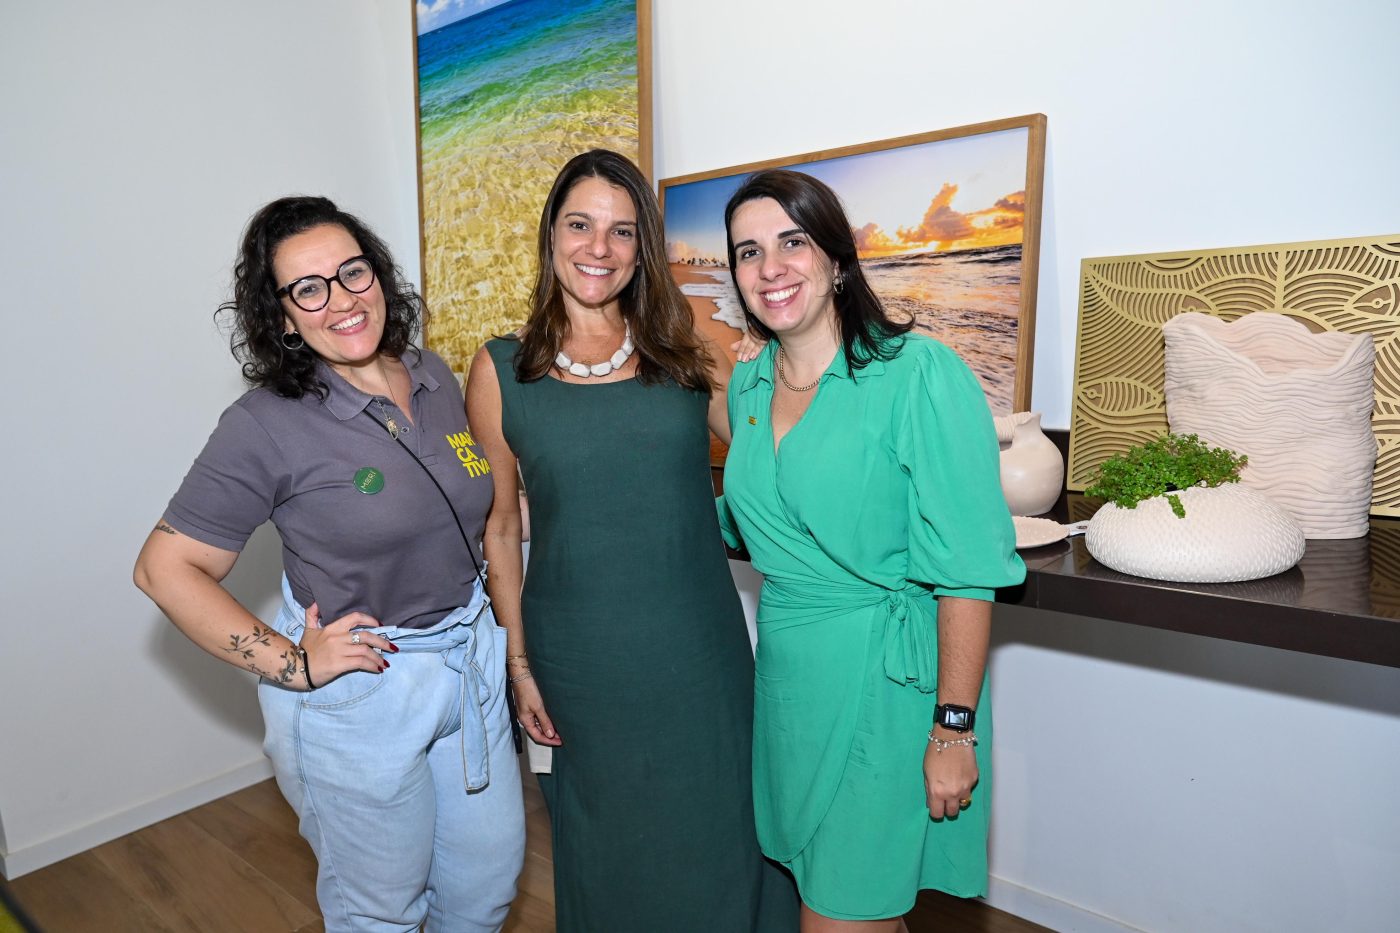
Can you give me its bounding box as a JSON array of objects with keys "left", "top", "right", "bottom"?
[{"left": 468, "top": 150, "right": 797, "bottom": 933}]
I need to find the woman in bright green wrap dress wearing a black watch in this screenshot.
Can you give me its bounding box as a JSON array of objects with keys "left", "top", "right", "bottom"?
[{"left": 721, "top": 171, "right": 1025, "bottom": 933}]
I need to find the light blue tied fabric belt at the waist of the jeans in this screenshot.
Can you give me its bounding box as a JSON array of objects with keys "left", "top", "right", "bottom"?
[{"left": 276, "top": 574, "right": 494, "bottom": 793}]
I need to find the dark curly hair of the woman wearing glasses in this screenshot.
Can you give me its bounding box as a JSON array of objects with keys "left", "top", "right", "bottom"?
[{"left": 216, "top": 195, "right": 427, "bottom": 398}]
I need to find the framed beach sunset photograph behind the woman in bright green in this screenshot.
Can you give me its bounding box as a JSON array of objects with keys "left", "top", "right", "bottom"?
[{"left": 661, "top": 113, "right": 1046, "bottom": 467}]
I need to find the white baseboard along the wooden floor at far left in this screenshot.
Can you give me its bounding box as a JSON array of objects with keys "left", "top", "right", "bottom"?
[{"left": 0, "top": 758, "right": 272, "bottom": 881}]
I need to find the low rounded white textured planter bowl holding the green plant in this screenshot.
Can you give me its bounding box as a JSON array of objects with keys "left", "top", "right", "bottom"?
[{"left": 1084, "top": 483, "right": 1306, "bottom": 583}]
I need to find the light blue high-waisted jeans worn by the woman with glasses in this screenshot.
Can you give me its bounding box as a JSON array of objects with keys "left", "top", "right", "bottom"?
[{"left": 258, "top": 577, "right": 525, "bottom": 933}]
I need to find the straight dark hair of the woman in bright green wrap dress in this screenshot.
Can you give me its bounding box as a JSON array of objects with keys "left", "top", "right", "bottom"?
[{"left": 724, "top": 168, "right": 914, "bottom": 375}]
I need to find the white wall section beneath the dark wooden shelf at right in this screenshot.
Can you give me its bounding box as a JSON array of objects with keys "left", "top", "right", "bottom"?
[{"left": 991, "top": 607, "right": 1400, "bottom": 933}]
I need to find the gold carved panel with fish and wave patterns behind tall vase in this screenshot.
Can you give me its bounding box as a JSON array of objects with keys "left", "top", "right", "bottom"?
[{"left": 1067, "top": 234, "right": 1400, "bottom": 516}]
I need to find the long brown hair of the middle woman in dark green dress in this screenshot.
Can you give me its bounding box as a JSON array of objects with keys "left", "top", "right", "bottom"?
[{"left": 515, "top": 148, "right": 714, "bottom": 394}]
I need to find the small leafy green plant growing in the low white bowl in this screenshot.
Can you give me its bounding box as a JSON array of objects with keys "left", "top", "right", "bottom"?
[{"left": 1084, "top": 434, "right": 1249, "bottom": 518}]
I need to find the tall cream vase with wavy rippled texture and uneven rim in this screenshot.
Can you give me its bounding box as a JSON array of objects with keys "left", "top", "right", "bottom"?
[{"left": 1162, "top": 311, "right": 1376, "bottom": 538}]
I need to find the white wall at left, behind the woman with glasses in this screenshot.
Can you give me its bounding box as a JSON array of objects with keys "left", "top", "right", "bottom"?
[{"left": 0, "top": 0, "right": 419, "bottom": 876}]
